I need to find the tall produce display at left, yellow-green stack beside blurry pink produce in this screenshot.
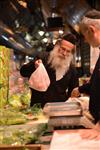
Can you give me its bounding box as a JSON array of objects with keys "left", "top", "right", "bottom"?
[{"left": 0, "top": 46, "right": 31, "bottom": 109}]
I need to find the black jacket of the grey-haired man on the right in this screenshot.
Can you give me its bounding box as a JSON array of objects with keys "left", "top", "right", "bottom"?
[{"left": 79, "top": 56, "right": 100, "bottom": 122}]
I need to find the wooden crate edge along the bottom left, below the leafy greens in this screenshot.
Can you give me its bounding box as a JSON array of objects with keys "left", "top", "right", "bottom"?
[{"left": 0, "top": 144, "right": 41, "bottom": 150}]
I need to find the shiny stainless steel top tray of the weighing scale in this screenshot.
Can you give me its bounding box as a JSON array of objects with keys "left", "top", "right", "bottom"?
[{"left": 43, "top": 102, "right": 82, "bottom": 117}]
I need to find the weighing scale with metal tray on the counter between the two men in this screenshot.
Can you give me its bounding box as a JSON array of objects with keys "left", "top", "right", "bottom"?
[{"left": 43, "top": 101, "right": 94, "bottom": 128}]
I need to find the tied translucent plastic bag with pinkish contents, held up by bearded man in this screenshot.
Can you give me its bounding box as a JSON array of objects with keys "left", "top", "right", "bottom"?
[{"left": 29, "top": 63, "right": 50, "bottom": 91}]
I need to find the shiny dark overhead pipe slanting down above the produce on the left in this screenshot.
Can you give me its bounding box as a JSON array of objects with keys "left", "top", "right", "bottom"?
[{"left": 0, "top": 21, "right": 32, "bottom": 55}]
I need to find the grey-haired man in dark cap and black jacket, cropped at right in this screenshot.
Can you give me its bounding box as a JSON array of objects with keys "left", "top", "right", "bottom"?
[{"left": 71, "top": 10, "right": 100, "bottom": 139}]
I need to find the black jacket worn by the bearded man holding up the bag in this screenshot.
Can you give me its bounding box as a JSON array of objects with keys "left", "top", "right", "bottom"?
[{"left": 20, "top": 52, "right": 78, "bottom": 107}]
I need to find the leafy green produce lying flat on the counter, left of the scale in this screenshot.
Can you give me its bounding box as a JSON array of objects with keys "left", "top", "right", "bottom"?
[{"left": 0, "top": 105, "right": 47, "bottom": 145}]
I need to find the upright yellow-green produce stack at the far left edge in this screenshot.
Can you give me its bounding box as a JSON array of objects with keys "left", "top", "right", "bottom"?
[{"left": 0, "top": 46, "right": 10, "bottom": 108}]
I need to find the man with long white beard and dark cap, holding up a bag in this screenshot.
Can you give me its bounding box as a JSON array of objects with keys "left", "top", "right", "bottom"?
[{"left": 20, "top": 34, "right": 78, "bottom": 107}]
